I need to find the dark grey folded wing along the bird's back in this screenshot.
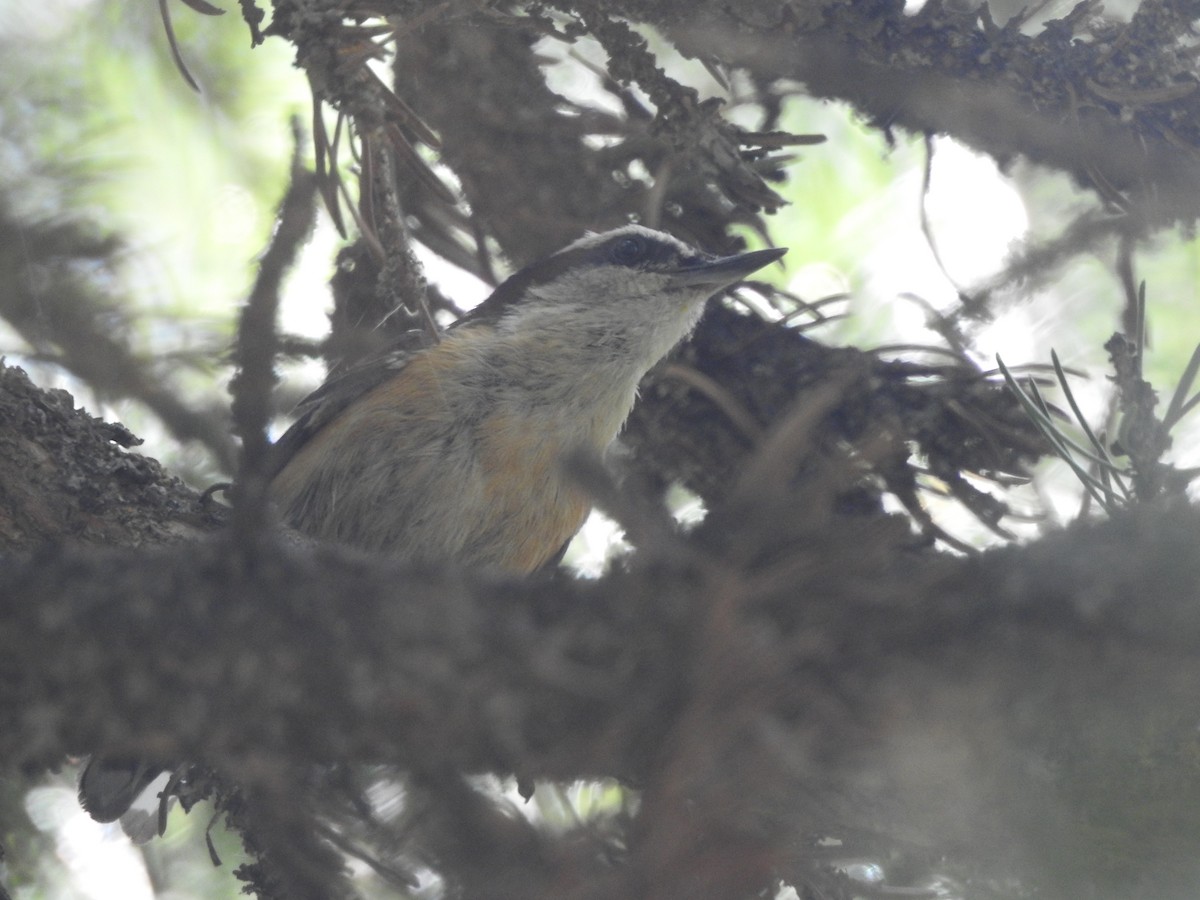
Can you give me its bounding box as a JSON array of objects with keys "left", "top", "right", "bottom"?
[{"left": 266, "top": 331, "right": 434, "bottom": 479}]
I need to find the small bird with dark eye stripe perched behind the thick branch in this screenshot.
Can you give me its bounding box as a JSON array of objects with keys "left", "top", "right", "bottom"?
[{"left": 79, "top": 224, "right": 787, "bottom": 838}]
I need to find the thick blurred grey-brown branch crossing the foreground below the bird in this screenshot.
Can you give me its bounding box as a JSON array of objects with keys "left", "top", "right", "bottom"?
[{"left": 0, "top": 362, "right": 1200, "bottom": 898}]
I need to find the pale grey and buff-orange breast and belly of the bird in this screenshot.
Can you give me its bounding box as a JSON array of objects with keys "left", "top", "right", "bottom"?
[{"left": 272, "top": 336, "right": 632, "bottom": 572}]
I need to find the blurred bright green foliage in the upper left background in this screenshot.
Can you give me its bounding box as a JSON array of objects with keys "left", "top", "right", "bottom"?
[{"left": 0, "top": 0, "right": 314, "bottom": 481}]
